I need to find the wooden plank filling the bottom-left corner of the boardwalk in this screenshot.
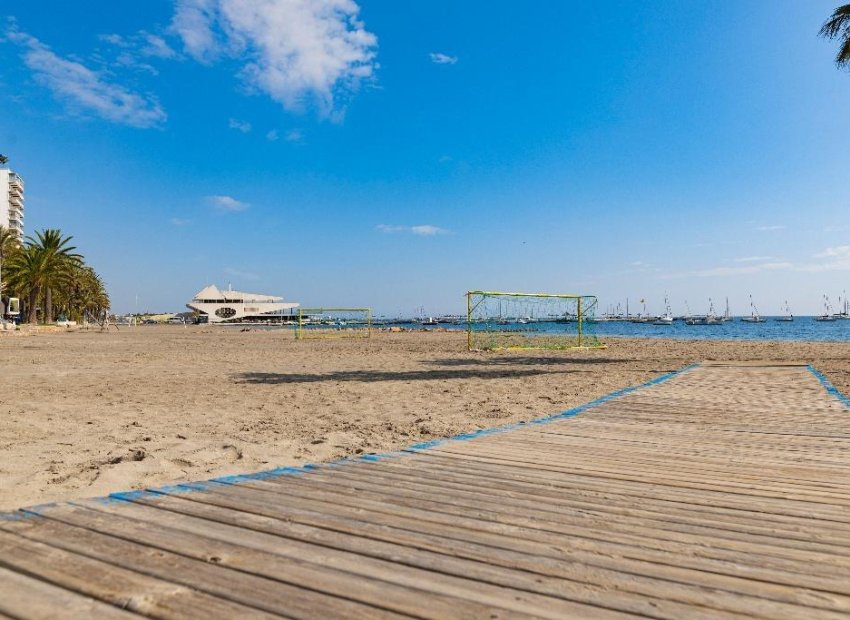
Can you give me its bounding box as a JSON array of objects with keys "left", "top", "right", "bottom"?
[{"left": 0, "top": 568, "right": 141, "bottom": 620}]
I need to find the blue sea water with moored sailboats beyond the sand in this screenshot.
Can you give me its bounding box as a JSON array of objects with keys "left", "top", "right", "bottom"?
[{"left": 392, "top": 316, "right": 850, "bottom": 342}]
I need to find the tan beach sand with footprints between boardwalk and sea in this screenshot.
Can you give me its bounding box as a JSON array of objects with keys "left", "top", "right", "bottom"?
[{"left": 0, "top": 326, "right": 850, "bottom": 509}]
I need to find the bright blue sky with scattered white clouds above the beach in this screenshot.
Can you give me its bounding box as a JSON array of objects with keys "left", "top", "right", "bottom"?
[{"left": 0, "top": 0, "right": 850, "bottom": 314}]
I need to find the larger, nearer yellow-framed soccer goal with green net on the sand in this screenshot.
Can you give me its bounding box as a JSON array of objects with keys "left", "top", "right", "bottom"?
[{"left": 466, "top": 291, "right": 605, "bottom": 351}]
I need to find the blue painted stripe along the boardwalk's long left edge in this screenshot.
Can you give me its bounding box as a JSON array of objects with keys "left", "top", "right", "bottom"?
[{"left": 0, "top": 364, "right": 696, "bottom": 520}]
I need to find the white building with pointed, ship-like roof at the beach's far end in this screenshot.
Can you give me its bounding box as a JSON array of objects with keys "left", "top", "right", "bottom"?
[{"left": 186, "top": 284, "right": 299, "bottom": 323}]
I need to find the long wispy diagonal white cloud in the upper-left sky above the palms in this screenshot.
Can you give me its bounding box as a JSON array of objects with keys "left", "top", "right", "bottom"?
[{"left": 7, "top": 27, "right": 167, "bottom": 127}]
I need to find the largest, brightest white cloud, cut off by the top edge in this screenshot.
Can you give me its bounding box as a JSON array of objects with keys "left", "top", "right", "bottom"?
[{"left": 171, "top": 0, "right": 378, "bottom": 115}]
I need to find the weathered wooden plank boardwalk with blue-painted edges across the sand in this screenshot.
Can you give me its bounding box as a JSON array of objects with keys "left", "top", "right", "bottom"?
[{"left": 0, "top": 365, "right": 850, "bottom": 620}]
